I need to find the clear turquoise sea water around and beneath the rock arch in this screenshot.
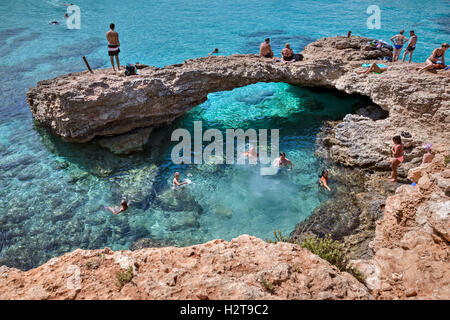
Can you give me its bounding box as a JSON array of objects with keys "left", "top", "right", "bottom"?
[{"left": 0, "top": 0, "right": 450, "bottom": 269}]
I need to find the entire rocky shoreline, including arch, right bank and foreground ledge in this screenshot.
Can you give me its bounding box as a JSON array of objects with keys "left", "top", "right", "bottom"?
[{"left": 0, "top": 37, "right": 450, "bottom": 299}]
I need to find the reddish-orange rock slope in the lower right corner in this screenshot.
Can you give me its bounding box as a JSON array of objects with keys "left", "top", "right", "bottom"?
[{"left": 354, "top": 145, "right": 450, "bottom": 299}]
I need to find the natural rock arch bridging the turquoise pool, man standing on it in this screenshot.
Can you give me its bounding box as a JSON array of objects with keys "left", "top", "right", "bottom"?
[{"left": 27, "top": 37, "right": 450, "bottom": 166}]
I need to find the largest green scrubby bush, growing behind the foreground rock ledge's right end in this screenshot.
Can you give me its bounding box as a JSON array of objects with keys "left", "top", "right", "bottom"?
[{"left": 266, "top": 230, "right": 365, "bottom": 284}]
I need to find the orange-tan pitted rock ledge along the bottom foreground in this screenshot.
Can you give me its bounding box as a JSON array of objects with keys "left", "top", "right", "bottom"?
[{"left": 0, "top": 235, "right": 372, "bottom": 300}]
